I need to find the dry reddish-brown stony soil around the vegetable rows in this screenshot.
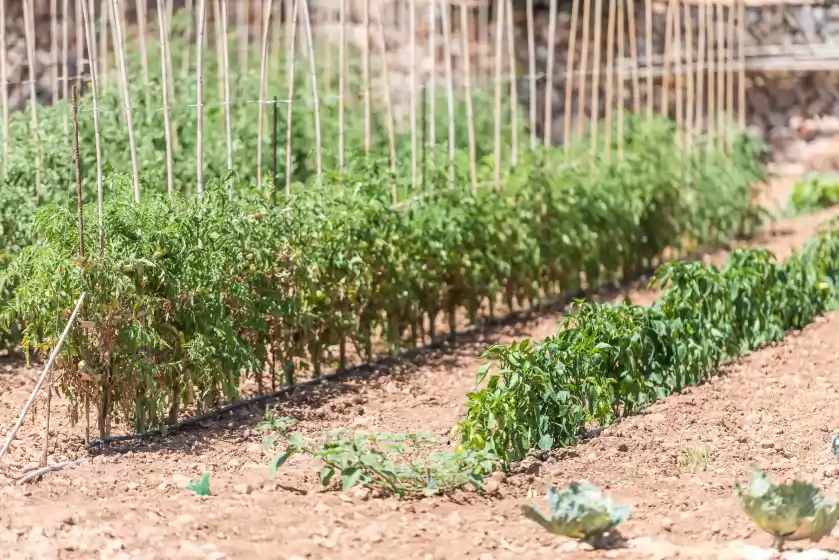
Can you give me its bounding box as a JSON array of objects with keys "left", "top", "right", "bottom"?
[{"left": 0, "top": 187, "right": 839, "bottom": 560}]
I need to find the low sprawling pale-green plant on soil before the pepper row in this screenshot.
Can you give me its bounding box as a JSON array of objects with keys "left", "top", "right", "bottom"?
[{"left": 261, "top": 418, "right": 495, "bottom": 498}]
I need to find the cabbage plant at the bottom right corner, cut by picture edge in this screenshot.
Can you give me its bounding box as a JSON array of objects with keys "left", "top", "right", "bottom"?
[{"left": 735, "top": 468, "right": 839, "bottom": 550}]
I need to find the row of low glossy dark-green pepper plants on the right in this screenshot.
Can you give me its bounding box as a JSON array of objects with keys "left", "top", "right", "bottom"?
[{"left": 459, "top": 224, "right": 839, "bottom": 465}]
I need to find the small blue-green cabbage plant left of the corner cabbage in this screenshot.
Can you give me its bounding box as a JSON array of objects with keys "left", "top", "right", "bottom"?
[{"left": 521, "top": 481, "right": 632, "bottom": 543}]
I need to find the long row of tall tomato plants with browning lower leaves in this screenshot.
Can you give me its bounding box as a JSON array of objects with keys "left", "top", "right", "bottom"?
[{"left": 3, "top": 105, "right": 762, "bottom": 435}]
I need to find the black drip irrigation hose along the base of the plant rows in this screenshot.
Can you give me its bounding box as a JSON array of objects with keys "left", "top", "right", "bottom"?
[{"left": 85, "top": 240, "right": 735, "bottom": 450}]
